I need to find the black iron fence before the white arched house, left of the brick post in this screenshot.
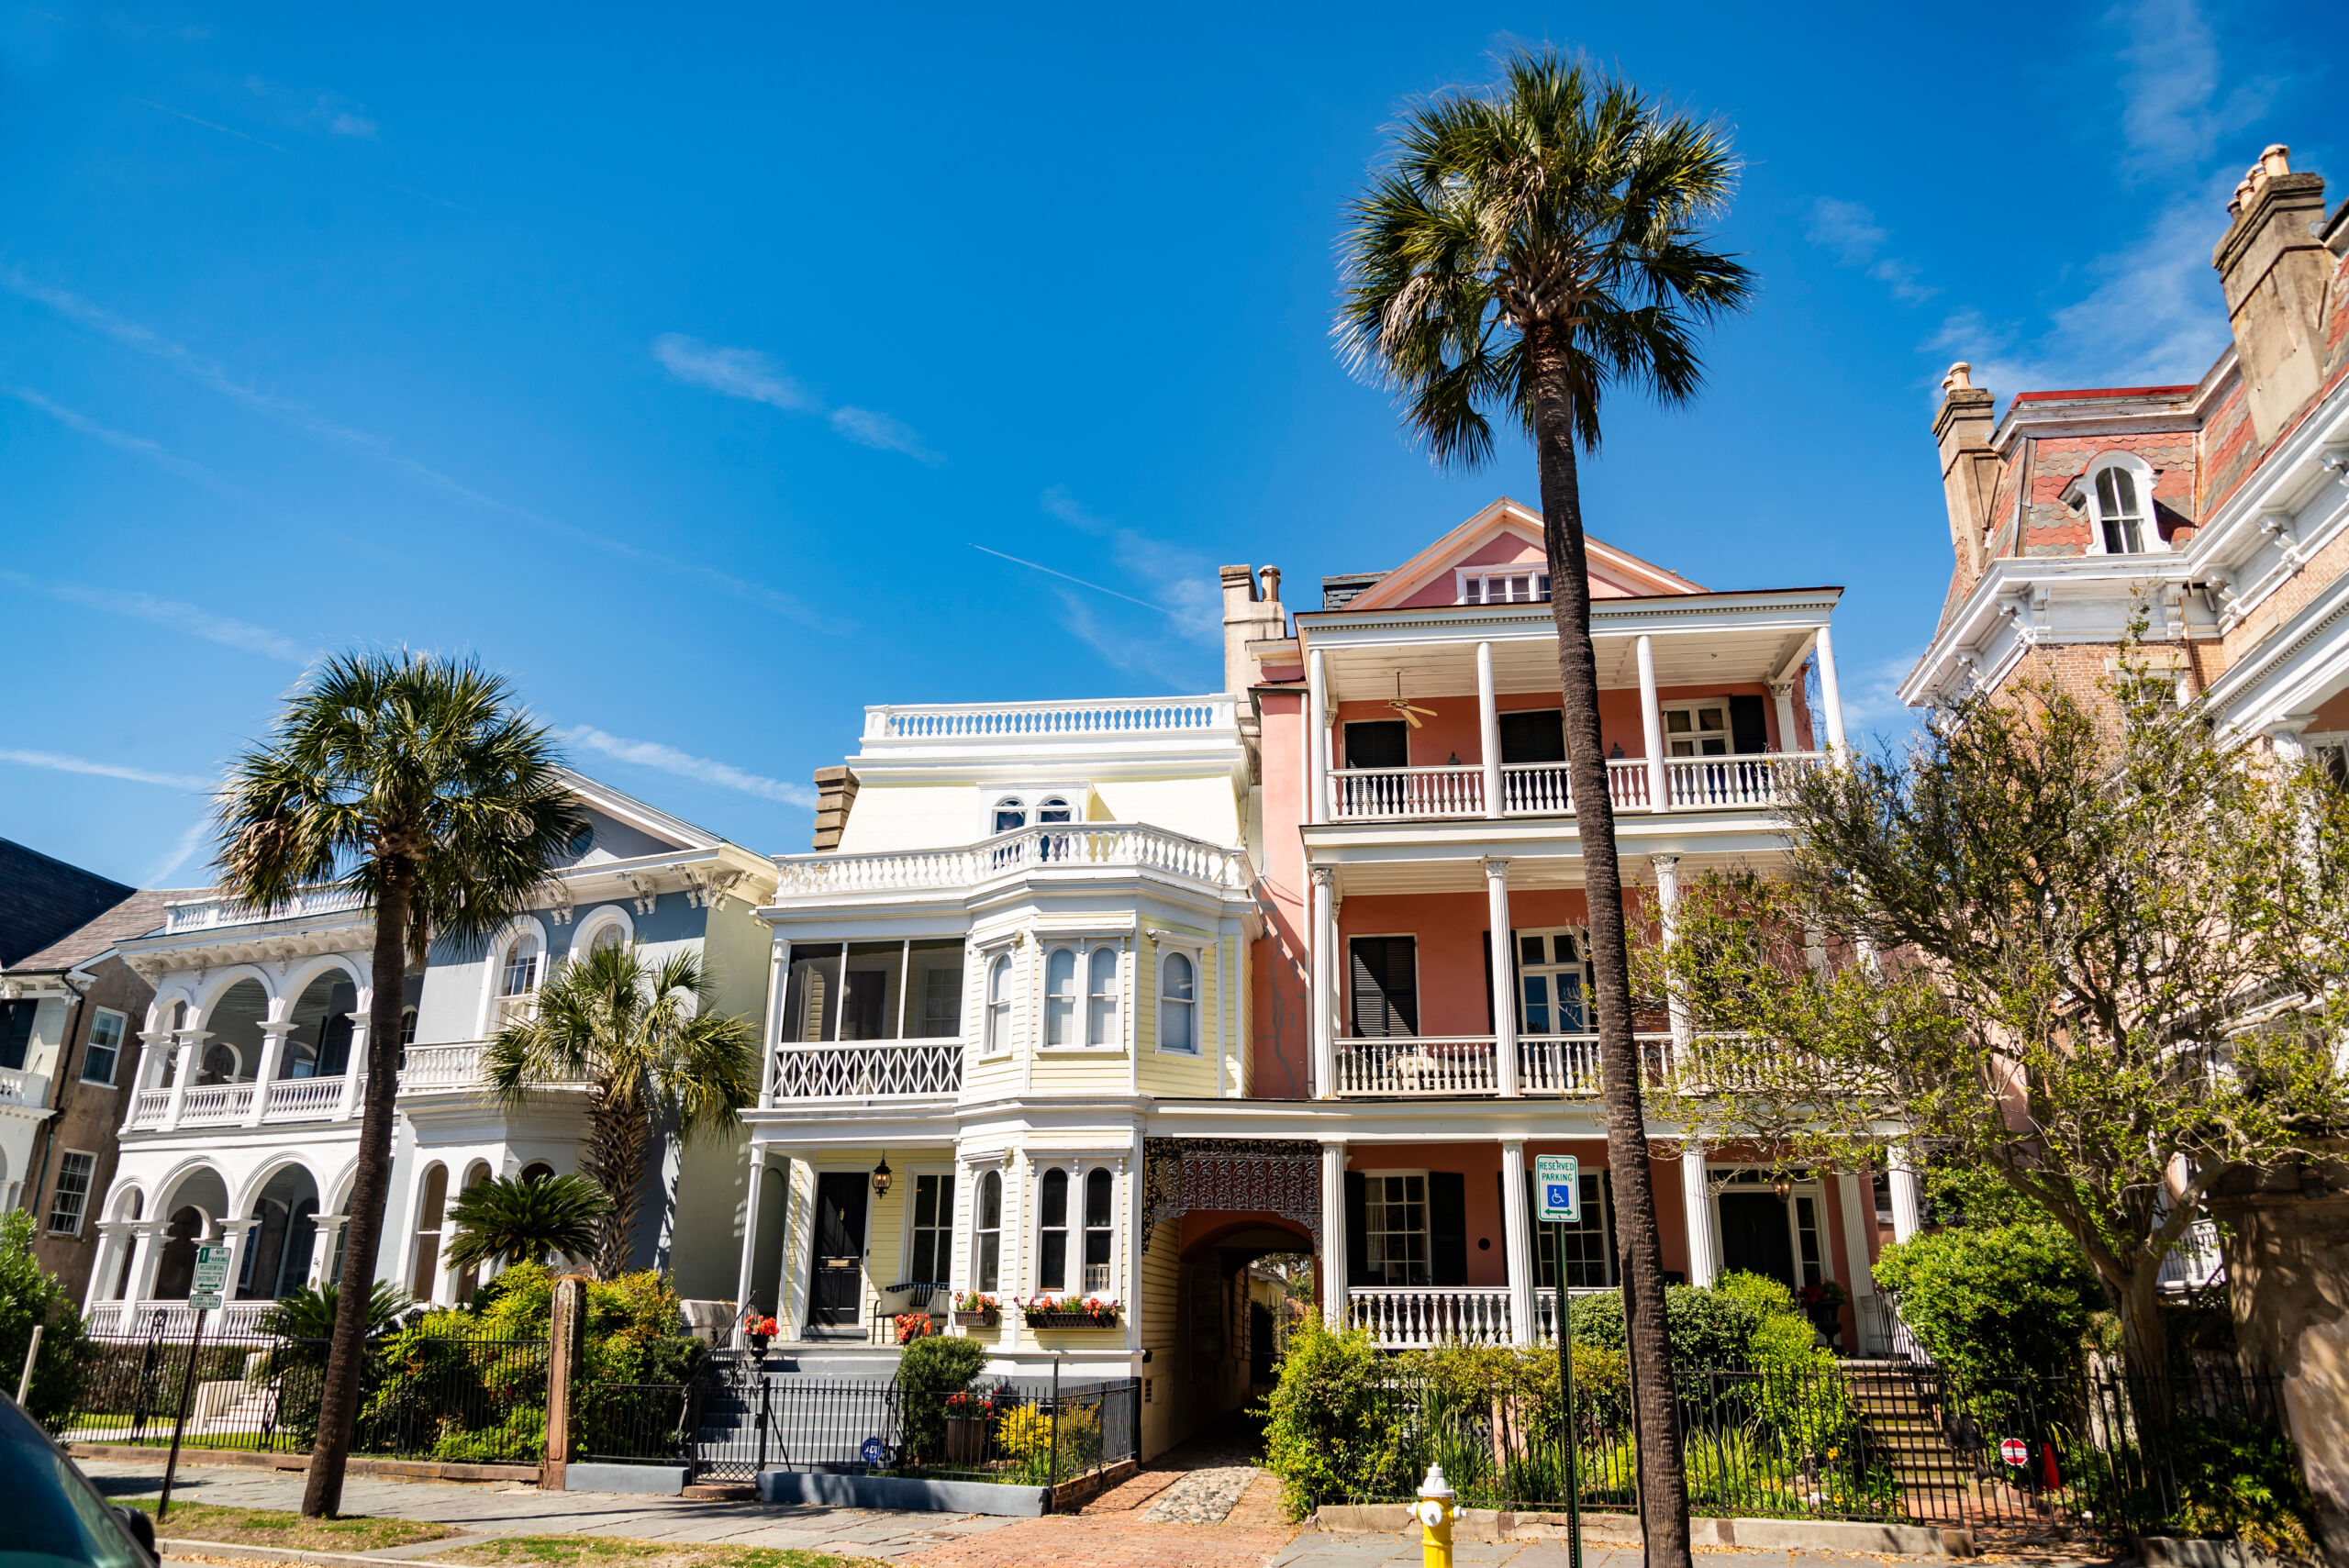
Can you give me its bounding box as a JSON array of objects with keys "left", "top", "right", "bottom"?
[{"left": 61, "top": 1331, "right": 547, "bottom": 1464}]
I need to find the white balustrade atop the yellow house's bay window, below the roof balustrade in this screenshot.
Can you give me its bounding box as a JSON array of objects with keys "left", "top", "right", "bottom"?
[{"left": 775, "top": 821, "right": 1254, "bottom": 899}]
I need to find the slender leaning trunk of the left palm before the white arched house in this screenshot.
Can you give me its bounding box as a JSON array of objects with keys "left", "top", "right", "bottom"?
[{"left": 301, "top": 863, "right": 408, "bottom": 1518}]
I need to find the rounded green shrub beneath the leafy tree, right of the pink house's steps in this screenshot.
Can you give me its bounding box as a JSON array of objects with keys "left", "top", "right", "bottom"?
[{"left": 1875, "top": 1220, "right": 2105, "bottom": 1378}]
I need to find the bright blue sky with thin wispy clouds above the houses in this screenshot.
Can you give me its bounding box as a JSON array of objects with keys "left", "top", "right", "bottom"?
[{"left": 0, "top": 0, "right": 2344, "bottom": 885}]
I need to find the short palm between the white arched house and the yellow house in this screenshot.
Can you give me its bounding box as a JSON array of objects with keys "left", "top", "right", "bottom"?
[{"left": 484, "top": 943, "right": 759, "bottom": 1279}]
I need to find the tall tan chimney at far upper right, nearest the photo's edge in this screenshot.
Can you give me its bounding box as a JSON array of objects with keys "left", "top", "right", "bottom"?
[{"left": 2210, "top": 143, "right": 2332, "bottom": 446}]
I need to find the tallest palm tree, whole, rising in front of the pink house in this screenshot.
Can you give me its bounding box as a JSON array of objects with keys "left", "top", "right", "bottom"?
[{"left": 1337, "top": 50, "right": 1753, "bottom": 1563}]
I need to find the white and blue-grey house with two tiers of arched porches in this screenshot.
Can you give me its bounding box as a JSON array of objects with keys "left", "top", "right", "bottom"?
[{"left": 87, "top": 774, "right": 775, "bottom": 1336}]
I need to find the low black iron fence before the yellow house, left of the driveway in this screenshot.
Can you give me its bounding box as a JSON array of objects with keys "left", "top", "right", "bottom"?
[{"left": 676, "top": 1362, "right": 1141, "bottom": 1485}]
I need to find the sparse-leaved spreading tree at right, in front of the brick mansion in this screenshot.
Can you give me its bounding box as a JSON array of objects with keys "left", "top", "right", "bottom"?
[{"left": 1640, "top": 651, "right": 2349, "bottom": 1375}]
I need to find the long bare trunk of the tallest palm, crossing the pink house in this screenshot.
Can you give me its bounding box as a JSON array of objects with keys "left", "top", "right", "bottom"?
[{"left": 1497, "top": 324, "right": 1689, "bottom": 1568}]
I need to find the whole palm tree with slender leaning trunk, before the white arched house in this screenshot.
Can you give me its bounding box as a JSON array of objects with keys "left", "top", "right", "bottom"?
[{"left": 218, "top": 652, "right": 587, "bottom": 1518}]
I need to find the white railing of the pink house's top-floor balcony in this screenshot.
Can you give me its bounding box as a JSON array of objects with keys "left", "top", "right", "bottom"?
[{"left": 1330, "top": 751, "right": 1825, "bottom": 821}]
